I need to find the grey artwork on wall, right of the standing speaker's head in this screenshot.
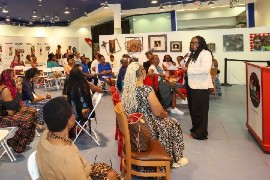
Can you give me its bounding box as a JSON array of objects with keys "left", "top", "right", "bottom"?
[{"left": 223, "top": 34, "right": 244, "bottom": 52}]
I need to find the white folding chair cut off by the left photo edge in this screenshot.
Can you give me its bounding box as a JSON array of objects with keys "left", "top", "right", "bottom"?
[{"left": 0, "top": 127, "right": 18, "bottom": 162}]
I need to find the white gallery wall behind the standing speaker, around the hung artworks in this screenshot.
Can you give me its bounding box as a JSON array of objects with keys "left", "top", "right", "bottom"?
[{"left": 99, "top": 27, "right": 270, "bottom": 84}]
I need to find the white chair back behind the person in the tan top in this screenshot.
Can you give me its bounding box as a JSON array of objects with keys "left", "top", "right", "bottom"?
[{"left": 27, "top": 151, "right": 39, "bottom": 180}]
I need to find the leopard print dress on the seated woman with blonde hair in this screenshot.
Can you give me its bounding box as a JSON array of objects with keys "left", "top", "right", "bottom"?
[{"left": 134, "top": 85, "right": 184, "bottom": 163}]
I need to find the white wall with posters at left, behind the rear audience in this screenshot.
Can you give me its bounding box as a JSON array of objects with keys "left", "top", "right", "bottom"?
[{"left": 0, "top": 25, "right": 92, "bottom": 71}]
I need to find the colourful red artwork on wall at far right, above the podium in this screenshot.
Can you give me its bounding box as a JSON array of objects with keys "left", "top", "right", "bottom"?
[{"left": 249, "top": 33, "right": 270, "bottom": 51}]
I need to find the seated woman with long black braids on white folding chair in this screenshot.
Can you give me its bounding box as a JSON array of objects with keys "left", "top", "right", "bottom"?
[{"left": 67, "top": 65, "right": 103, "bottom": 136}]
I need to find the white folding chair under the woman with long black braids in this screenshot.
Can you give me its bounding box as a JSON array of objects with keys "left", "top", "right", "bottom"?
[{"left": 74, "top": 93, "right": 103, "bottom": 146}]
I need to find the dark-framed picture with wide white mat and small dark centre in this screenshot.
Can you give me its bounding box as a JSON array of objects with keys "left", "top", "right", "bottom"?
[{"left": 148, "top": 34, "right": 167, "bottom": 52}]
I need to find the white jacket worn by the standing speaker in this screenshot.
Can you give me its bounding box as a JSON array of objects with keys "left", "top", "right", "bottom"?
[{"left": 187, "top": 50, "right": 213, "bottom": 89}]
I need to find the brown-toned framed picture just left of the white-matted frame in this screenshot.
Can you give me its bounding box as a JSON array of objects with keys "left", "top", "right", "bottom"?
[{"left": 126, "top": 37, "right": 143, "bottom": 53}]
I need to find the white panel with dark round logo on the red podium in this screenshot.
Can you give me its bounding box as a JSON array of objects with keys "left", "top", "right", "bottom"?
[{"left": 247, "top": 65, "right": 262, "bottom": 139}]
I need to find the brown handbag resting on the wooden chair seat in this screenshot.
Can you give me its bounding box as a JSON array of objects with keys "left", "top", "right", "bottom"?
[{"left": 128, "top": 113, "right": 151, "bottom": 152}]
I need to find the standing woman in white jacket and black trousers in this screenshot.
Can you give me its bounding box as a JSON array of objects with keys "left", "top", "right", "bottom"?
[{"left": 184, "top": 36, "right": 213, "bottom": 140}]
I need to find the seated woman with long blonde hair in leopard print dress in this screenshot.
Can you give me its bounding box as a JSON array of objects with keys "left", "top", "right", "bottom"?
[{"left": 122, "top": 62, "right": 188, "bottom": 167}]
